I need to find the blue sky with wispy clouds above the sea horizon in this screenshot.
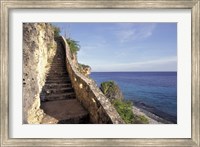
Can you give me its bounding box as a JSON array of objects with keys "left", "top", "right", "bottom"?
[{"left": 53, "top": 23, "right": 177, "bottom": 71}]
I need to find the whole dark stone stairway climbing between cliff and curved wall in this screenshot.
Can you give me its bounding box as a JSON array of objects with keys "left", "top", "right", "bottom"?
[{"left": 40, "top": 40, "right": 89, "bottom": 124}]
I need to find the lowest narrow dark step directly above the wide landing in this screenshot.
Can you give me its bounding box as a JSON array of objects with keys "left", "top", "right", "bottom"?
[{"left": 41, "top": 92, "right": 76, "bottom": 102}]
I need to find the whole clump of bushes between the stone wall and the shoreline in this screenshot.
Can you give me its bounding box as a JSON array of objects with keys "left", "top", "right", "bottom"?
[{"left": 100, "top": 81, "right": 149, "bottom": 124}]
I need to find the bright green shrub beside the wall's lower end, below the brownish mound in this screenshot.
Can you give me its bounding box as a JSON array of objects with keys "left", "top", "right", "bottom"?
[{"left": 112, "top": 99, "right": 134, "bottom": 124}]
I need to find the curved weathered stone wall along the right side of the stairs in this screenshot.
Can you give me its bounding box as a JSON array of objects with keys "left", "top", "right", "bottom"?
[{"left": 61, "top": 37, "right": 124, "bottom": 124}]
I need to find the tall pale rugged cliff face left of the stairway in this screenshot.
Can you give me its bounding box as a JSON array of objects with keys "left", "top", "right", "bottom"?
[{"left": 23, "top": 23, "right": 56, "bottom": 124}]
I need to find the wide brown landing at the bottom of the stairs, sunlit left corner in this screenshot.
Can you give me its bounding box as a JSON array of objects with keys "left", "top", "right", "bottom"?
[{"left": 41, "top": 99, "right": 89, "bottom": 124}]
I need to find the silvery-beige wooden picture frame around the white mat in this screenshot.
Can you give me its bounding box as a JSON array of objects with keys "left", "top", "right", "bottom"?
[{"left": 0, "top": 0, "right": 200, "bottom": 147}]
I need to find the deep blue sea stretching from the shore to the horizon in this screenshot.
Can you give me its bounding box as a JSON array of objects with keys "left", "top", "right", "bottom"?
[{"left": 90, "top": 72, "right": 177, "bottom": 123}]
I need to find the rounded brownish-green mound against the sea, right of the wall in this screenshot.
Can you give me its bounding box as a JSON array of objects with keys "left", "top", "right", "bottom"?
[{"left": 100, "top": 81, "right": 124, "bottom": 101}]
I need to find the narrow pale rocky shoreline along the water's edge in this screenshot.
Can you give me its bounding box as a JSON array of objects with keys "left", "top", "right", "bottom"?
[{"left": 132, "top": 106, "right": 173, "bottom": 124}]
